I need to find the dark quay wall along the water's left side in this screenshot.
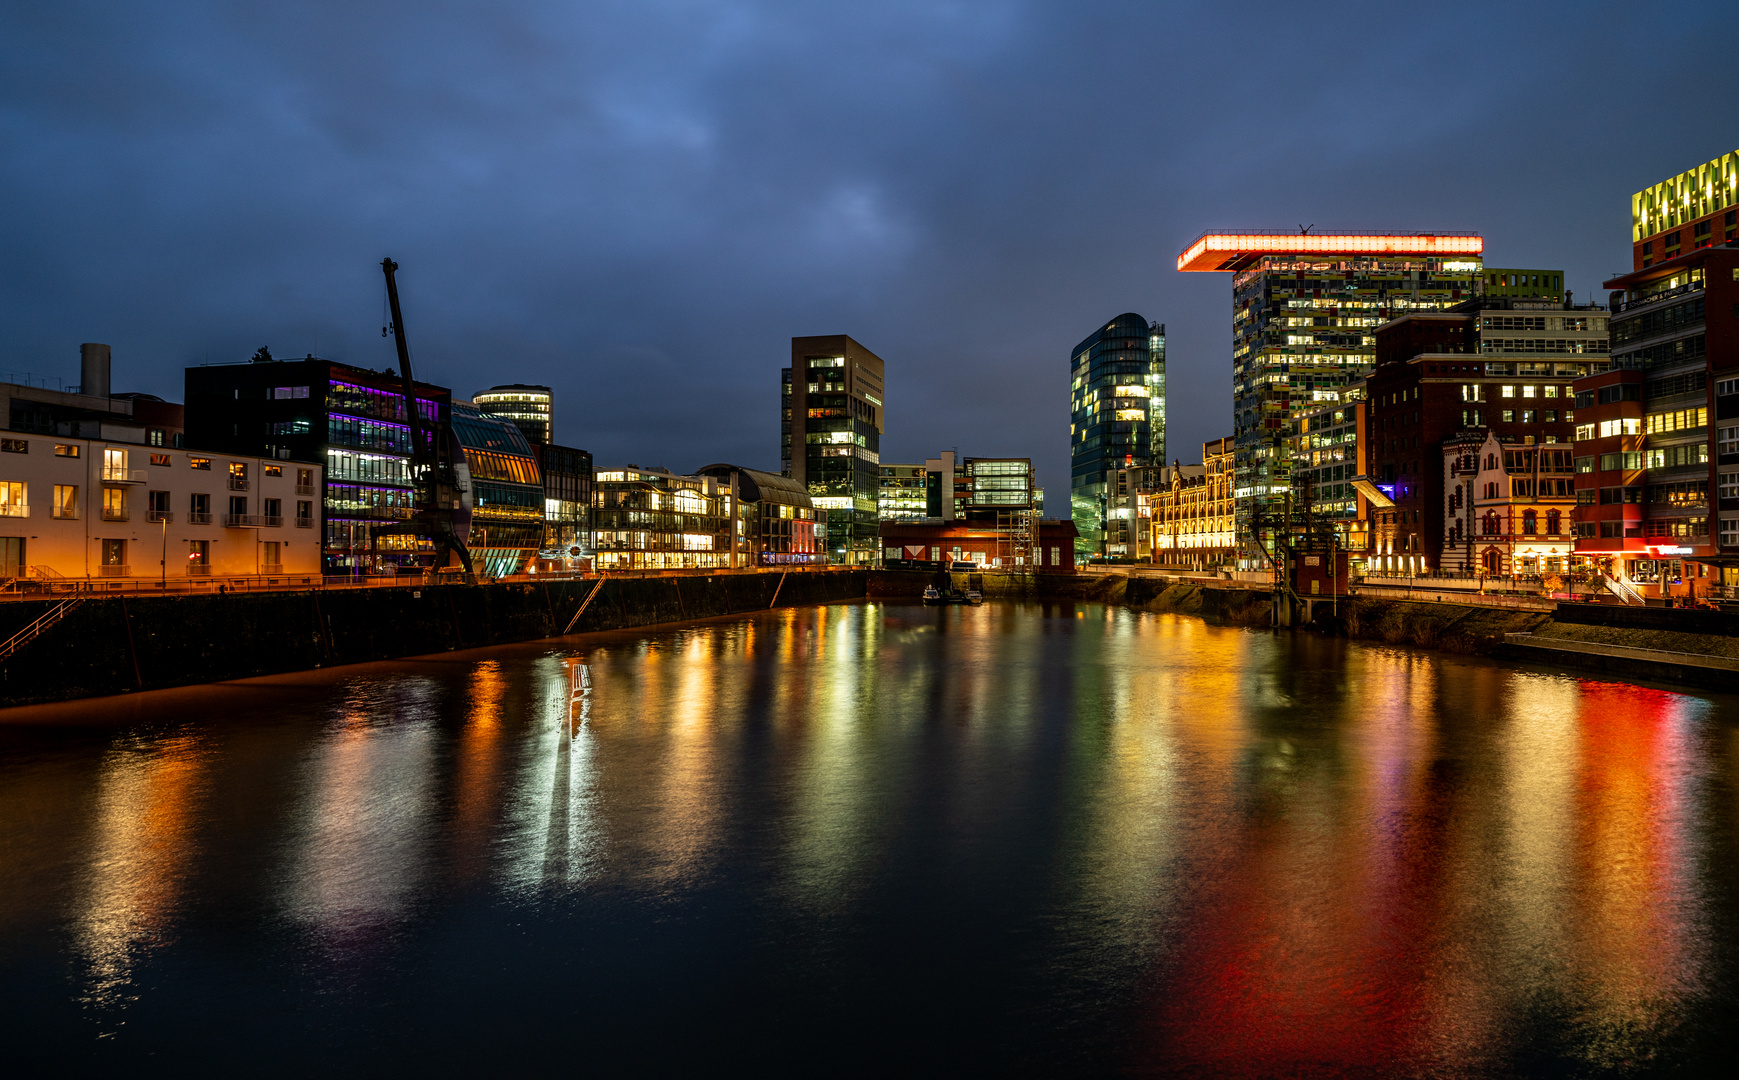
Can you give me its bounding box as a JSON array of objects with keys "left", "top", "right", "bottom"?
[{"left": 0, "top": 570, "right": 869, "bottom": 706}]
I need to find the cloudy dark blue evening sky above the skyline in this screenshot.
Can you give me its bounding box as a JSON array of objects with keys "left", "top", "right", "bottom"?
[{"left": 0, "top": 0, "right": 1739, "bottom": 493}]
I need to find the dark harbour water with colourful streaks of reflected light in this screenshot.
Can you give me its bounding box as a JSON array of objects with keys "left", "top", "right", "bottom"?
[{"left": 0, "top": 602, "right": 1739, "bottom": 1077}]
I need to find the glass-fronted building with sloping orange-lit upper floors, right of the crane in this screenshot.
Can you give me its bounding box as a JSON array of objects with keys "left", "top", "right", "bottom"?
[{"left": 450, "top": 400, "right": 544, "bottom": 577}]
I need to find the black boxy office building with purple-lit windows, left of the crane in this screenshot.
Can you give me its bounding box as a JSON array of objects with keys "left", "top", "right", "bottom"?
[{"left": 186, "top": 357, "right": 459, "bottom": 574}]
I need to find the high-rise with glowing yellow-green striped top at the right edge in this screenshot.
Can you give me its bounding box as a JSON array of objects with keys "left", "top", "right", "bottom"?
[{"left": 1576, "top": 151, "right": 1739, "bottom": 597}]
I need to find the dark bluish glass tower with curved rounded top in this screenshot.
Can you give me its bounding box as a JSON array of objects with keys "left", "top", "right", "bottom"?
[{"left": 1069, "top": 311, "right": 1165, "bottom": 557}]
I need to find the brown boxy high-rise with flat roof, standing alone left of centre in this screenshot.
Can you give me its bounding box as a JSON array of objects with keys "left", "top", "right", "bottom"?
[{"left": 781, "top": 334, "right": 885, "bottom": 565}]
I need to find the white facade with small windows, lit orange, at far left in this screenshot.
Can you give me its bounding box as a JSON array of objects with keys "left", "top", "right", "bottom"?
[{"left": 0, "top": 431, "right": 323, "bottom": 581}]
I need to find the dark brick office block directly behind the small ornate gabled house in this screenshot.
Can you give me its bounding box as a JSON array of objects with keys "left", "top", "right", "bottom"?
[{"left": 1351, "top": 286, "right": 1609, "bottom": 574}]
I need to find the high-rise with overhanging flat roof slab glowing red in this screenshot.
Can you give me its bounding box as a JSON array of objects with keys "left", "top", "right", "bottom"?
[{"left": 1177, "top": 231, "right": 1485, "bottom": 567}]
